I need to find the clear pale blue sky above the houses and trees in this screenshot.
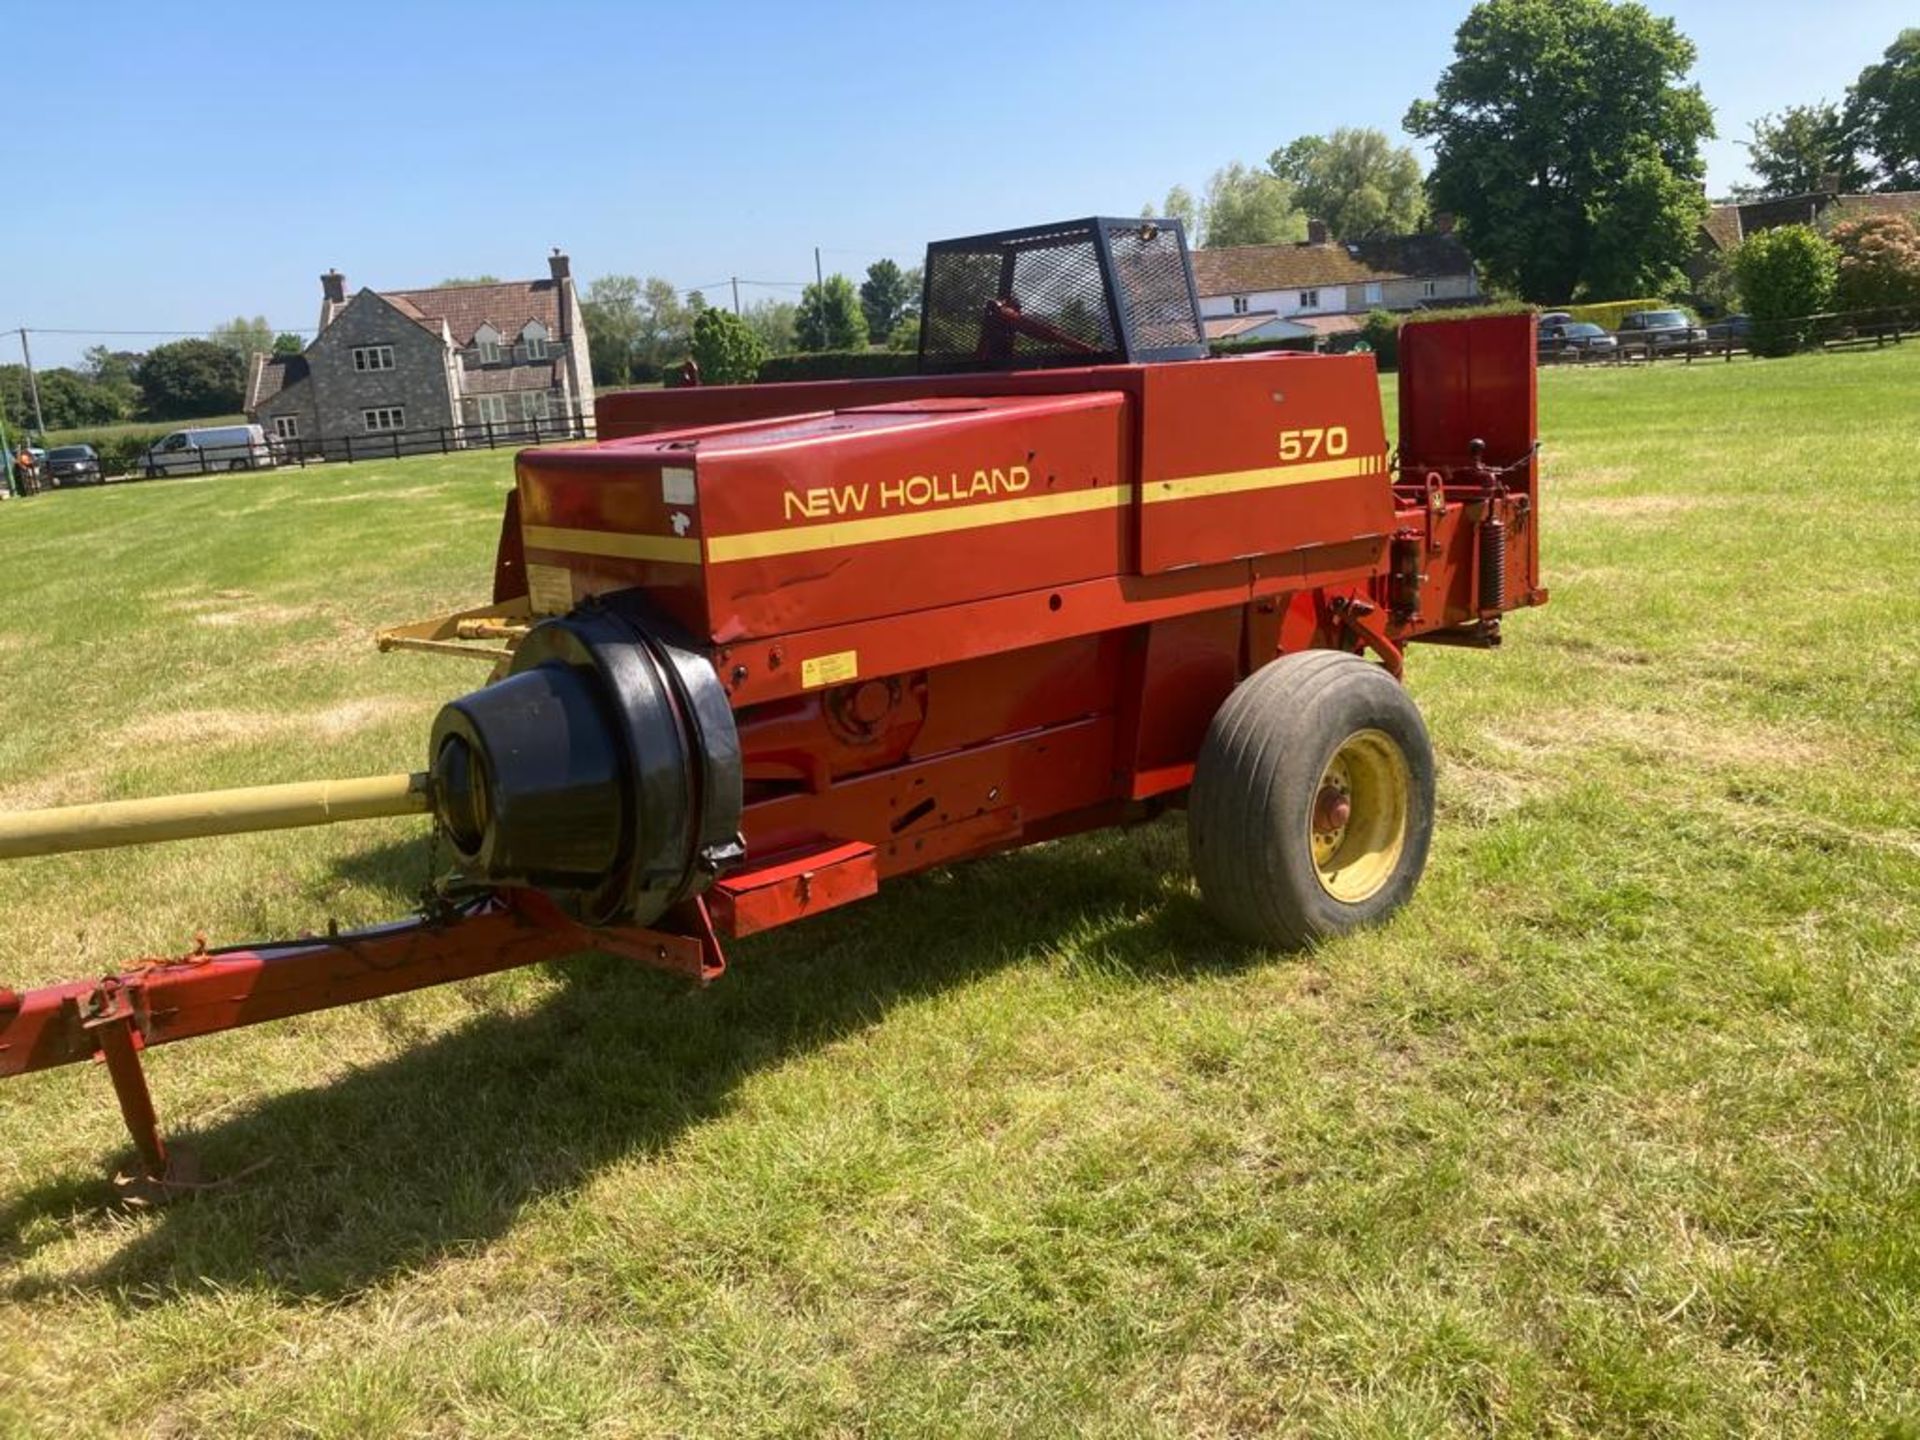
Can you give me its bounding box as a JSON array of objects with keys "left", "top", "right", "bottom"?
[{"left": 0, "top": 0, "right": 1914, "bottom": 365}]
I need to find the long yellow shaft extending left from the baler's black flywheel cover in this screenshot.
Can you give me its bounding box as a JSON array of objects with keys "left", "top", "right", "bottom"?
[{"left": 0, "top": 774, "right": 432, "bottom": 860}]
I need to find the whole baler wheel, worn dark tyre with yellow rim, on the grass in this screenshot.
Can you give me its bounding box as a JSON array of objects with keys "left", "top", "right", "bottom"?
[{"left": 1187, "top": 651, "right": 1434, "bottom": 948}]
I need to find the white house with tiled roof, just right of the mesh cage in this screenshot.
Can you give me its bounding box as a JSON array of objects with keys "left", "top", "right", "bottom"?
[{"left": 1192, "top": 215, "right": 1480, "bottom": 344}]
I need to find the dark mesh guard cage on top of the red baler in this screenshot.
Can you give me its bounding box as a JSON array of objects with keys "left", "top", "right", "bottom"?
[{"left": 920, "top": 217, "right": 1208, "bottom": 374}]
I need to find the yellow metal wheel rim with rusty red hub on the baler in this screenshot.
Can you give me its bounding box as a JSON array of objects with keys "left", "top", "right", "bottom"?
[{"left": 1308, "top": 730, "right": 1413, "bottom": 904}]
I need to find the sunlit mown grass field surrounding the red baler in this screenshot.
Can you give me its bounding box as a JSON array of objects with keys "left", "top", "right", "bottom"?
[{"left": 0, "top": 346, "right": 1920, "bottom": 1436}]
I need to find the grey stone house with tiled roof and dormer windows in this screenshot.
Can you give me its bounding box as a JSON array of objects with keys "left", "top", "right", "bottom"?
[{"left": 246, "top": 250, "right": 593, "bottom": 453}]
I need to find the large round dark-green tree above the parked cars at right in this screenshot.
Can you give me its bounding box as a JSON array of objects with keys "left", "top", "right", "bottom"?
[{"left": 1405, "top": 0, "right": 1713, "bottom": 301}]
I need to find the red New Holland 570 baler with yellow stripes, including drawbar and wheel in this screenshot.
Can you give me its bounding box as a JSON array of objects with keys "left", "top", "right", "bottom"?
[{"left": 0, "top": 219, "right": 1546, "bottom": 1190}]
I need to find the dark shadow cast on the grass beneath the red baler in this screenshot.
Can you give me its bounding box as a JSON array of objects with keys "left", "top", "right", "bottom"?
[{"left": 0, "top": 816, "right": 1260, "bottom": 1308}]
